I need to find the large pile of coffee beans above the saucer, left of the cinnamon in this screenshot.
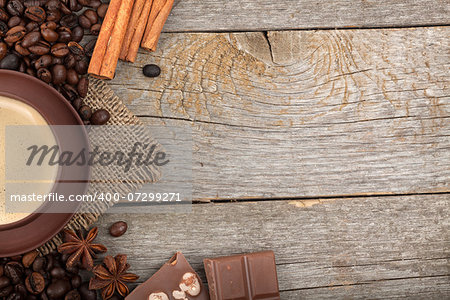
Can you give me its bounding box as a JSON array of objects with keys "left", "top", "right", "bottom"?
[{"left": 0, "top": 0, "right": 110, "bottom": 125}]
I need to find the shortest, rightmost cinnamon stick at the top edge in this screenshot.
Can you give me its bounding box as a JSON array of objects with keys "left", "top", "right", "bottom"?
[{"left": 141, "top": 0, "right": 174, "bottom": 51}]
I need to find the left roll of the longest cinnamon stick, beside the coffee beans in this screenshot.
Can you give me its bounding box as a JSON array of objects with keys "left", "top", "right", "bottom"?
[{"left": 88, "top": 0, "right": 122, "bottom": 77}]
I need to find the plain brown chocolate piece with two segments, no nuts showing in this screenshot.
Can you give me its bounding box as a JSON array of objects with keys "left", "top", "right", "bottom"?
[{"left": 203, "top": 251, "right": 280, "bottom": 300}]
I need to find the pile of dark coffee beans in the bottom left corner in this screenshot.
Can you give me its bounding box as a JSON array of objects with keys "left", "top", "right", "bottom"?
[{"left": 0, "top": 251, "right": 102, "bottom": 300}]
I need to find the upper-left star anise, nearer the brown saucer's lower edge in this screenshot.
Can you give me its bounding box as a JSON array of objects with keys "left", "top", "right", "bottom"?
[{"left": 58, "top": 227, "right": 107, "bottom": 270}]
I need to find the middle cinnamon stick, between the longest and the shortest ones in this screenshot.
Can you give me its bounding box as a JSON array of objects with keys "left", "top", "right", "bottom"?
[{"left": 119, "top": 0, "right": 153, "bottom": 62}]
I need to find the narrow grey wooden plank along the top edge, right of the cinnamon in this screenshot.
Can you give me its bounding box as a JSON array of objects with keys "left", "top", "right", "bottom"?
[{"left": 164, "top": 0, "right": 450, "bottom": 32}]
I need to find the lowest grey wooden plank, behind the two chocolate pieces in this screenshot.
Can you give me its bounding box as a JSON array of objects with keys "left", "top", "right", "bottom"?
[{"left": 98, "top": 194, "right": 450, "bottom": 299}]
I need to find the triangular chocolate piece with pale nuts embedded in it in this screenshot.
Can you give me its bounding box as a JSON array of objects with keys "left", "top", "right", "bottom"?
[{"left": 125, "top": 252, "right": 209, "bottom": 300}]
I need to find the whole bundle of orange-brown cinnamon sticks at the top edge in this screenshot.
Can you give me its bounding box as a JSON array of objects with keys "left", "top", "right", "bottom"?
[{"left": 88, "top": 0, "right": 174, "bottom": 79}]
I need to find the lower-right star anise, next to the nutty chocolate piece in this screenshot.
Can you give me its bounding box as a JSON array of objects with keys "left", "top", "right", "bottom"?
[{"left": 89, "top": 254, "right": 139, "bottom": 300}]
